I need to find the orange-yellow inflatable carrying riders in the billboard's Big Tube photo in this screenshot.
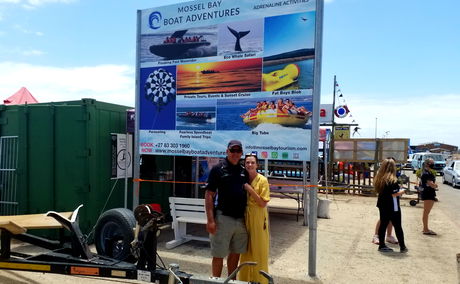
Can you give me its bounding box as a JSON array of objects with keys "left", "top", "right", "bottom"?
[{"left": 241, "top": 98, "right": 312, "bottom": 128}]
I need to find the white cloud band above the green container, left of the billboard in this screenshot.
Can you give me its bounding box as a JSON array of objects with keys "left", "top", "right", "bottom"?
[{"left": 0, "top": 62, "right": 135, "bottom": 106}]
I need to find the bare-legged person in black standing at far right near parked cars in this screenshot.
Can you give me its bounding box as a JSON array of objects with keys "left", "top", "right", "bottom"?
[{"left": 420, "top": 158, "right": 438, "bottom": 235}]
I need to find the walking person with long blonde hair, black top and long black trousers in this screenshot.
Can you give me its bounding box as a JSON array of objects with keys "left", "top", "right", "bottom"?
[{"left": 374, "top": 159, "right": 408, "bottom": 253}]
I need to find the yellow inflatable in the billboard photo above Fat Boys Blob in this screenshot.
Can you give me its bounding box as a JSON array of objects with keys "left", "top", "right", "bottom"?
[{"left": 262, "top": 63, "right": 300, "bottom": 91}]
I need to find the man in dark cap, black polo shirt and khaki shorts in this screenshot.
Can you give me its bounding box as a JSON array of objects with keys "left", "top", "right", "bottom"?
[{"left": 205, "top": 140, "right": 249, "bottom": 278}]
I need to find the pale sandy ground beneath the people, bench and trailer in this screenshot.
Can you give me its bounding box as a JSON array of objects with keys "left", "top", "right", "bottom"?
[{"left": 0, "top": 174, "right": 460, "bottom": 284}]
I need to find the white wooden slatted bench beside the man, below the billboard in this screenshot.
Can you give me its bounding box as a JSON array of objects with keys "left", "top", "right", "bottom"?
[{"left": 166, "top": 197, "right": 209, "bottom": 249}]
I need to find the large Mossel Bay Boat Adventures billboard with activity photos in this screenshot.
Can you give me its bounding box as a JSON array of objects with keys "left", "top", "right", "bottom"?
[{"left": 136, "top": 0, "right": 319, "bottom": 161}]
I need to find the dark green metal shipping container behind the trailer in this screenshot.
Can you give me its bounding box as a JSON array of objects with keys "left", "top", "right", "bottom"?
[{"left": 0, "top": 99, "right": 132, "bottom": 233}]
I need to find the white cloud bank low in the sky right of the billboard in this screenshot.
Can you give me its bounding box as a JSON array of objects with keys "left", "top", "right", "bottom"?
[{"left": 336, "top": 94, "right": 460, "bottom": 146}]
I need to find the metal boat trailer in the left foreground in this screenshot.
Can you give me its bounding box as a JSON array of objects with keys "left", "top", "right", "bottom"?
[{"left": 0, "top": 205, "right": 274, "bottom": 284}]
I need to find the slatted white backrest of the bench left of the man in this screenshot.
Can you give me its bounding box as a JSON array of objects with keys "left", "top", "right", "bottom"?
[{"left": 169, "top": 197, "right": 206, "bottom": 219}]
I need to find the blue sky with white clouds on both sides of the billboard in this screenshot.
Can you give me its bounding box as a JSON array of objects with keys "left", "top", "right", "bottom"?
[{"left": 0, "top": 0, "right": 460, "bottom": 145}]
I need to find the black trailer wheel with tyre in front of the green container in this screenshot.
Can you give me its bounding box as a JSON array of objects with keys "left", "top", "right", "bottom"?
[{"left": 94, "top": 208, "right": 136, "bottom": 261}]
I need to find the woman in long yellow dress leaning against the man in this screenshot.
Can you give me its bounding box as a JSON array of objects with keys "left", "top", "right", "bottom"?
[{"left": 238, "top": 154, "right": 270, "bottom": 283}]
